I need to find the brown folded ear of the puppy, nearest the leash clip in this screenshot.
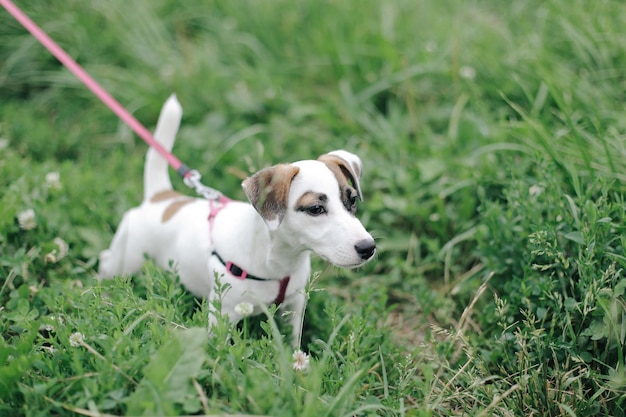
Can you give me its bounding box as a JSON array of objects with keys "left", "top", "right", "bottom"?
[{"left": 241, "top": 164, "right": 300, "bottom": 230}]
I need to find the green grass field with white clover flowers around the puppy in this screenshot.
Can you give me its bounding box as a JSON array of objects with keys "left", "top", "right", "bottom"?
[{"left": 0, "top": 0, "right": 626, "bottom": 416}]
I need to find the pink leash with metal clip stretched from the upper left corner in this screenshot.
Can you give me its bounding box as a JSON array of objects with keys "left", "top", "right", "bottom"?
[{"left": 0, "top": 0, "right": 220, "bottom": 199}]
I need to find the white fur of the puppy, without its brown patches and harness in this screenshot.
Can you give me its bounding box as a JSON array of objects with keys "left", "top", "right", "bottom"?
[{"left": 99, "top": 96, "right": 374, "bottom": 345}]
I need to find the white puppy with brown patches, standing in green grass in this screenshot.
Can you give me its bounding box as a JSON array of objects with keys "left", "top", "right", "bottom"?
[{"left": 98, "top": 95, "right": 376, "bottom": 347}]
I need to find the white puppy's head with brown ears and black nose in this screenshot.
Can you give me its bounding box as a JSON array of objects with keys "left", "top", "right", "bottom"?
[{"left": 243, "top": 150, "right": 376, "bottom": 267}]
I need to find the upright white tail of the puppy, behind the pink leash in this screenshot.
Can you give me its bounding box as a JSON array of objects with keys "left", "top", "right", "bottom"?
[{"left": 143, "top": 94, "right": 183, "bottom": 200}]
